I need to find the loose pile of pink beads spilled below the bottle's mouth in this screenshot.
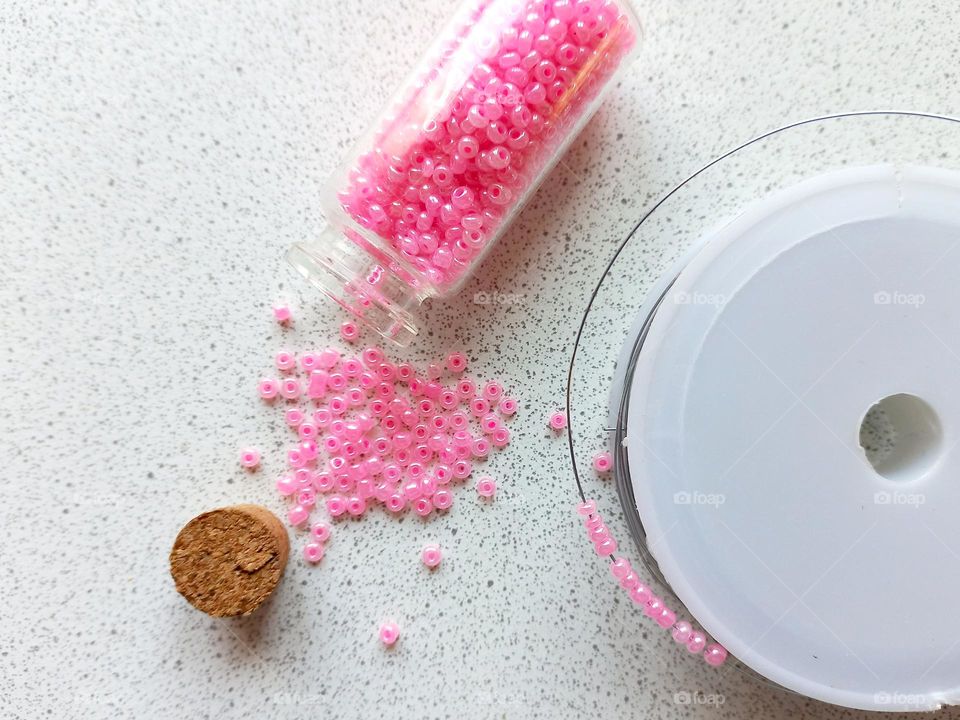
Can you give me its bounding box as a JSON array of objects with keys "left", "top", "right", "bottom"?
[{"left": 258, "top": 347, "right": 517, "bottom": 562}]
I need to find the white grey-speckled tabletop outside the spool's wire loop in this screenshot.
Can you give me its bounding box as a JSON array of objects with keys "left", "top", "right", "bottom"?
[{"left": 0, "top": 0, "right": 960, "bottom": 719}]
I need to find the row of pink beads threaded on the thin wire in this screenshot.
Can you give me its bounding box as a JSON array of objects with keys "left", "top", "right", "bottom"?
[{"left": 577, "top": 500, "right": 727, "bottom": 667}]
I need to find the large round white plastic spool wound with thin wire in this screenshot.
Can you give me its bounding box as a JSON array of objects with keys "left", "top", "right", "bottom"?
[{"left": 627, "top": 166, "right": 960, "bottom": 711}]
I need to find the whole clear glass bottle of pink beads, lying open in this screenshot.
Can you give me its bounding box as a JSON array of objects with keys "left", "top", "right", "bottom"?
[{"left": 287, "top": 0, "right": 640, "bottom": 345}]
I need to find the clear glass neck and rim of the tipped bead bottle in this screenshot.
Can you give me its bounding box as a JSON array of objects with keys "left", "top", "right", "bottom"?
[{"left": 286, "top": 226, "right": 432, "bottom": 347}]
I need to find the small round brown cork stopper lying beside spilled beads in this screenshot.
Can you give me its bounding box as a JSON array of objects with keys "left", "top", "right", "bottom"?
[{"left": 170, "top": 505, "right": 290, "bottom": 617}]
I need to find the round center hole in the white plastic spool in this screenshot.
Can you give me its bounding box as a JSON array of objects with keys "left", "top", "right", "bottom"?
[{"left": 860, "top": 393, "right": 943, "bottom": 482}]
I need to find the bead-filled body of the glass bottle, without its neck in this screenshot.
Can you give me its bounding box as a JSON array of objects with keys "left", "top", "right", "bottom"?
[{"left": 337, "top": 0, "right": 636, "bottom": 289}]
